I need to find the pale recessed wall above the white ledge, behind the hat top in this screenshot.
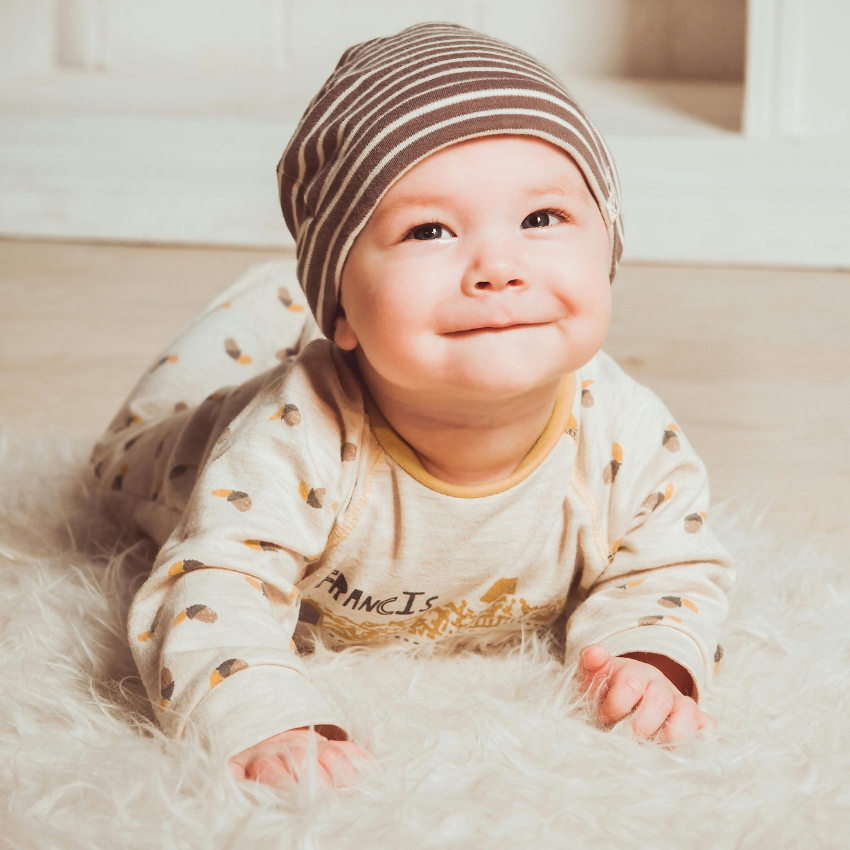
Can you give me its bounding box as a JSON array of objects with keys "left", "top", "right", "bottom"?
[{"left": 9, "top": 0, "right": 746, "bottom": 86}]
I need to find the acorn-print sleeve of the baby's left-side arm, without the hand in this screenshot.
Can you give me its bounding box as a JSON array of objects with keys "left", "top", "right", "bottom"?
[{"left": 129, "top": 340, "right": 363, "bottom": 775}]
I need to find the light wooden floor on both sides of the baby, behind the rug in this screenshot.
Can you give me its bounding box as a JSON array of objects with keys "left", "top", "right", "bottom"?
[{"left": 0, "top": 241, "right": 850, "bottom": 554}]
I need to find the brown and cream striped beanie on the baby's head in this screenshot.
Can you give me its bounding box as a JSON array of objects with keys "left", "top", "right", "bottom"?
[{"left": 277, "top": 23, "right": 623, "bottom": 338}]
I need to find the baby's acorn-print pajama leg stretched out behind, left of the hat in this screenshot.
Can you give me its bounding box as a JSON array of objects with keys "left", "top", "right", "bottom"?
[{"left": 91, "top": 260, "right": 321, "bottom": 545}]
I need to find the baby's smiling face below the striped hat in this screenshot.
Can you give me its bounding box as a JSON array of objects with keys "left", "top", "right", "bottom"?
[{"left": 335, "top": 136, "right": 611, "bottom": 399}]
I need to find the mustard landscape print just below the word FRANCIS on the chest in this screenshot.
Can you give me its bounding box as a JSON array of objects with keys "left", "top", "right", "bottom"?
[{"left": 306, "top": 578, "right": 566, "bottom": 642}]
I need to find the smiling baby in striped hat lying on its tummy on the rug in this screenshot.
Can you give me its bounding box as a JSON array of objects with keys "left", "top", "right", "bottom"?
[{"left": 94, "top": 24, "right": 733, "bottom": 787}]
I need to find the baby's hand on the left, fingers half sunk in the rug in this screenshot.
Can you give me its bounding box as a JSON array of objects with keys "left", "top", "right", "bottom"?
[{"left": 230, "top": 726, "right": 369, "bottom": 790}]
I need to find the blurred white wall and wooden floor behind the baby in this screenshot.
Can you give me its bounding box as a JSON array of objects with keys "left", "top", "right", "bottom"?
[{"left": 0, "top": 0, "right": 850, "bottom": 551}]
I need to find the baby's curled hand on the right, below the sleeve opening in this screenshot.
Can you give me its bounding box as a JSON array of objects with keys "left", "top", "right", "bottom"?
[{"left": 578, "top": 644, "right": 717, "bottom": 743}]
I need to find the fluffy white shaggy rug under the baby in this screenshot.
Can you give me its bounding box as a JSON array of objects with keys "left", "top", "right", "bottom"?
[{"left": 0, "top": 431, "right": 850, "bottom": 850}]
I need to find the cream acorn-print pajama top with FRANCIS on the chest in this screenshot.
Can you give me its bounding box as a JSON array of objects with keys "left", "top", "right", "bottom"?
[{"left": 121, "top": 308, "right": 733, "bottom": 756}]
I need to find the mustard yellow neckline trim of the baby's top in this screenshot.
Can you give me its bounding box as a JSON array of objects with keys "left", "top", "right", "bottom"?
[{"left": 363, "top": 373, "right": 576, "bottom": 499}]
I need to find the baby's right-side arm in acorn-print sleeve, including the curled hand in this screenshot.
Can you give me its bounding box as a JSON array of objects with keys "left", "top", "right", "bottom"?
[{"left": 567, "top": 380, "right": 734, "bottom": 741}]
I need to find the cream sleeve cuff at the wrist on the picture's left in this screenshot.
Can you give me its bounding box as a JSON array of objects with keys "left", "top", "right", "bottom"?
[{"left": 190, "top": 665, "right": 348, "bottom": 760}]
